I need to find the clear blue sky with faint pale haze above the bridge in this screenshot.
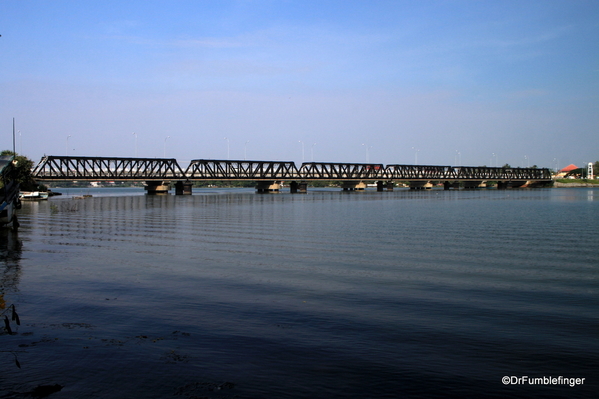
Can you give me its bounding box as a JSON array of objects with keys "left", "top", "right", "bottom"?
[{"left": 0, "top": 0, "right": 599, "bottom": 168}]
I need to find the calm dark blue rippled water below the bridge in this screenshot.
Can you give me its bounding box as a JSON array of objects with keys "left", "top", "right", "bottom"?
[{"left": 0, "top": 188, "right": 599, "bottom": 398}]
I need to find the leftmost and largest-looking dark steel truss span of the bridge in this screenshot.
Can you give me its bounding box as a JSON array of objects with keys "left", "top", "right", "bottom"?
[{"left": 33, "top": 156, "right": 185, "bottom": 181}]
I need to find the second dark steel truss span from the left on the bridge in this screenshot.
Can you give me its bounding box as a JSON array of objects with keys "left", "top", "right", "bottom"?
[{"left": 185, "top": 159, "right": 299, "bottom": 180}]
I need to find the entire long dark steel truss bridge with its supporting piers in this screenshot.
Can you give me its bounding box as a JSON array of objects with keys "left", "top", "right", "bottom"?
[{"left": 33, "top": 156, "right": 551, "bottom": 194}]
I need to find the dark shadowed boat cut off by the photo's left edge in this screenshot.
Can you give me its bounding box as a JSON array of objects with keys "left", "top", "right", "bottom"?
[{"left": 0, "top": 155, "right": 21, "bottom": 228}]
